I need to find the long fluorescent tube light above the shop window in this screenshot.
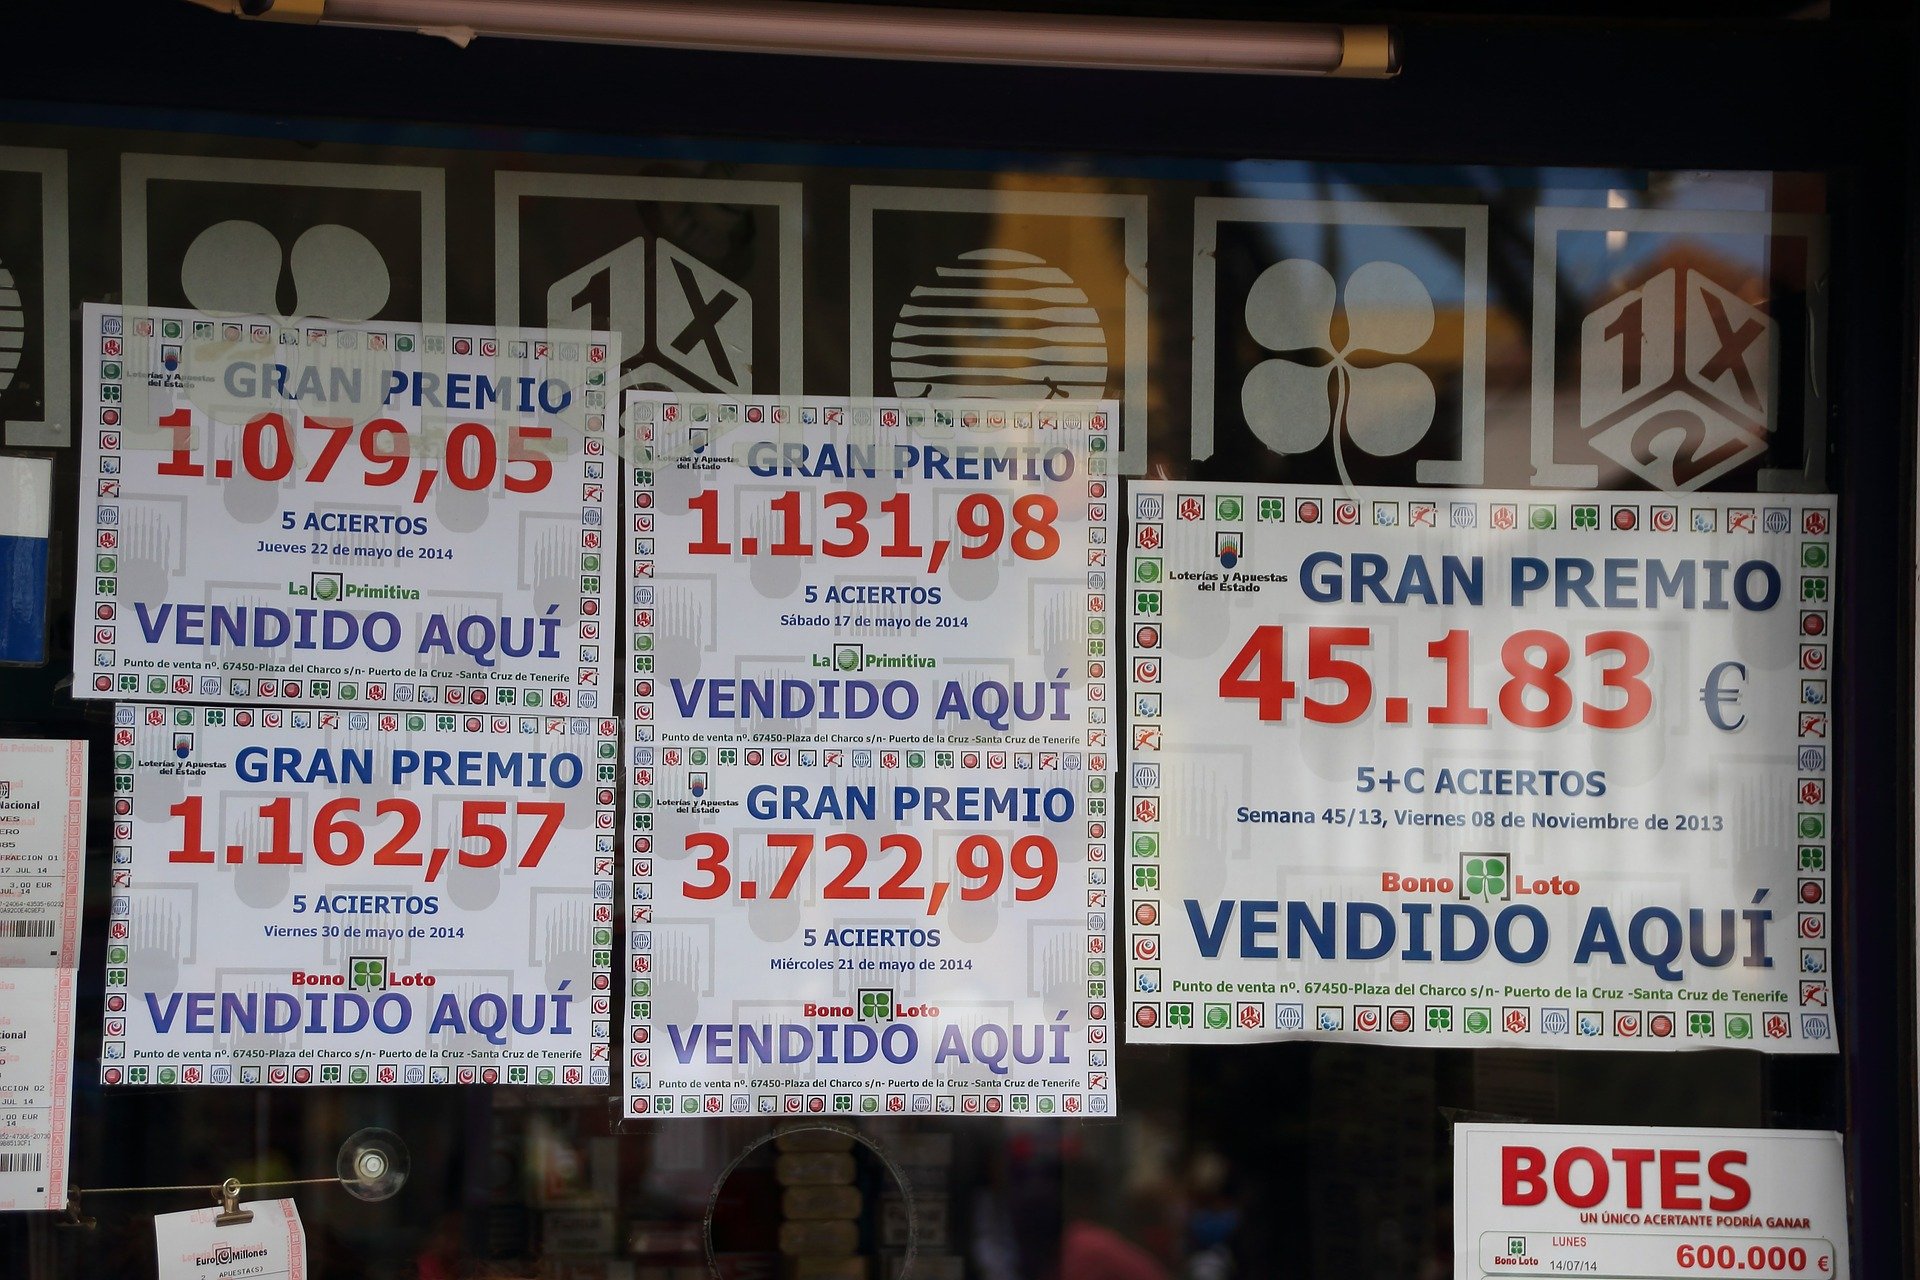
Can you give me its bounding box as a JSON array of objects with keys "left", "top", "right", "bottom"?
[{"left": 192, "top": 0, "right": 1400, "bottom": 79}]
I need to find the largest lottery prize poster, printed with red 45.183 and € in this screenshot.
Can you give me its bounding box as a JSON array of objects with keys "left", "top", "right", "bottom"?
[{"left": 1127, "top": 484, "right": 1836, "bottom": 1054}]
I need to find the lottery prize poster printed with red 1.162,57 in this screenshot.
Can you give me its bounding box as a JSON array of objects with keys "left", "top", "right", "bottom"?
[{"left": 102, "top": 702, "right": 618, "bottom": 1086}]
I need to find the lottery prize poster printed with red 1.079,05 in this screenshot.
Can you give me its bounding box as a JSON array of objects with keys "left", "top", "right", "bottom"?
[{"left": 75, "top": 305, "right": 618, "bottom": 714}]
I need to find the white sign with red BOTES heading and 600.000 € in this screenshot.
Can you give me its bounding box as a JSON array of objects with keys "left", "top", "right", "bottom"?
[{"left": 1453, "top": 1125, "right": 1853, "bottom": 1280}]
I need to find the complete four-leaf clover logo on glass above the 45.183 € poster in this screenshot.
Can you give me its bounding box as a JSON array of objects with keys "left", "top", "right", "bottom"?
[{"left": 1240, "top": 257, "right": 1438, "bottom": 484}]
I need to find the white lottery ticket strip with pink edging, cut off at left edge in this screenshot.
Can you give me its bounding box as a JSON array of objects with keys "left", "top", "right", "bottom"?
[{"left": 0, "top": 739, "right": 86, "bottom": 1209}]
